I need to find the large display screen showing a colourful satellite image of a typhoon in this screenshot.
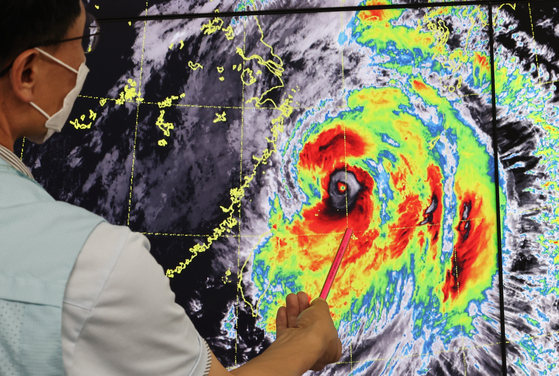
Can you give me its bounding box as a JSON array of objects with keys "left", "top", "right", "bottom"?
[{"left": 16, "top": 0, "right": 559, "bottom": 375}]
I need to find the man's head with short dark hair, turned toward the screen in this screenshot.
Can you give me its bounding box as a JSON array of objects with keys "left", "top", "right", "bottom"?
[{"left": 0, "top": 0, "right": 86, "bottom": 149}]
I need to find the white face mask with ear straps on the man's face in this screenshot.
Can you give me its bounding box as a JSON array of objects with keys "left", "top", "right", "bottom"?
[{"left": 27, "top": 48, "right": 89, "bottom": 144}]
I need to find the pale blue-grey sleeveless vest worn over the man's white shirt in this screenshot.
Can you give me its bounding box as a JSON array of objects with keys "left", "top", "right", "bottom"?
[{"left": 0, "top": 159, "right": 103, "bottom": 376}]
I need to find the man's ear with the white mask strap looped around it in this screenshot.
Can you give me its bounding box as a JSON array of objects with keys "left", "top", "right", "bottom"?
[{"left": 10, "top": 49, "right": 40, "bottom": 103}]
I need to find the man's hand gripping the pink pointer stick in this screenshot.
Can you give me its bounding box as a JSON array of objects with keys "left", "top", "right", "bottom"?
[{"left": 276, "top": 292, "right": 342, "bottom": 371}]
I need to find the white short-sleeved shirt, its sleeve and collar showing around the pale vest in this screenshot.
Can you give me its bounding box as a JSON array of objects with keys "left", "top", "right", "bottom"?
[{"left": 0, "top": 145, "right": 211, "bottom": 376}]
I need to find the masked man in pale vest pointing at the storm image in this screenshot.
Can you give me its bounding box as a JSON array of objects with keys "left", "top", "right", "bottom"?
[{"left": 0, "top": 0, "right": 341, "bottom": 376}]
